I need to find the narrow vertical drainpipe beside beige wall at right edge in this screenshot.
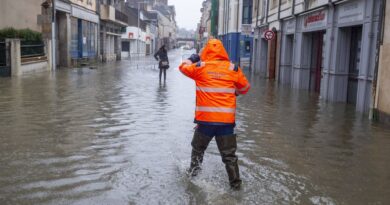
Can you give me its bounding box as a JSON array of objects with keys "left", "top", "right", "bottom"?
[{"left": 369, "top": 0, "right": 387, "bottom": 121}]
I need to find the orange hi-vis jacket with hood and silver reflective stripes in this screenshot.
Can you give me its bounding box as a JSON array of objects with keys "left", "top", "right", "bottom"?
[{"left": 179, "top": 39, "right": 250, "bottom": 124}]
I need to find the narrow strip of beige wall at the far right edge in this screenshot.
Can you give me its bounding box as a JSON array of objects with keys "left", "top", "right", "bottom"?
[{"left": 377, "top": 0, "right": 390, "bottom": 115}]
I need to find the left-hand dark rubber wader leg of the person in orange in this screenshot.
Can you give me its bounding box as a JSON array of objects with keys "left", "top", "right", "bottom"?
[{"left": 187, "top": 130, "right": 212, "bottom": 176}]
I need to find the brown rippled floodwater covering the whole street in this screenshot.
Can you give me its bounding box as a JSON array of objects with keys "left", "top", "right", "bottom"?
[{"left": 0, "top": 50, "right": 390, "bottom": 205}]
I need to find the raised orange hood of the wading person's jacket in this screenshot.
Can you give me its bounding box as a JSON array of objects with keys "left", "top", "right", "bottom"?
[{"left": 200, "top": 39, "right": 229, "bottom": 61}]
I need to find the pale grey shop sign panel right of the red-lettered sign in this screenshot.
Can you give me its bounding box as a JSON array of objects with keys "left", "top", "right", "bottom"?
[{"left": 338, "top": 1, "right": 364, "bottom": 23}]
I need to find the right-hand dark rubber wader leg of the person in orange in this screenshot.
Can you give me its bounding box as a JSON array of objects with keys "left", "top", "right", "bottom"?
[{"left": 215, "top": 134, "right": 242, "bottom": 190}]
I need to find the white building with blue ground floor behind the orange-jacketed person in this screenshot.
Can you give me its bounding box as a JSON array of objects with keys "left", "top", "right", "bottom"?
[{"left": 218, "top": 0, "right": 253, "bottom": 64}]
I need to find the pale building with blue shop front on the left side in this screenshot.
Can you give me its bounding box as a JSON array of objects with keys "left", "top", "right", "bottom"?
[{"left": 55, "top": 0, "right": 100, "bottom": 67}]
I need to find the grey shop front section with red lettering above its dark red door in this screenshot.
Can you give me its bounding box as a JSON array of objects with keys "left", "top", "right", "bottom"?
[{"left": 290, "top": 9, "right": 329, "bottom": 93}]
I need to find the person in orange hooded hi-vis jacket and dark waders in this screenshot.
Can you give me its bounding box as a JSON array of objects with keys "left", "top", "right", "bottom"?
[{"left": 179, "top": 39, "right": 250, "bottom": 189}]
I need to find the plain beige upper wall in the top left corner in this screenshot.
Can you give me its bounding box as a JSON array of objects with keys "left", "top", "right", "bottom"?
[{"left": 0, "top": 0, "right": 43, "bottom": 32}]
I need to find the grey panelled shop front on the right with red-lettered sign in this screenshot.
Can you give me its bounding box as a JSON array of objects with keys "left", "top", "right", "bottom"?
[{"left": 279, "top": 0, "right": 380, "bottom": 112}]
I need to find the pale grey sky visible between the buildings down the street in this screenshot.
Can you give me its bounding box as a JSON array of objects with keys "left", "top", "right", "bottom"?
[{"left": 168, "top": 0, "right": 203, "bottom": 30}]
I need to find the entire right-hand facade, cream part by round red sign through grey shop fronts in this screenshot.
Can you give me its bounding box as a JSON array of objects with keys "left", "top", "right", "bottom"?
[{"left": 252, "top": 0, "right": 381, "bottom": 112}]
